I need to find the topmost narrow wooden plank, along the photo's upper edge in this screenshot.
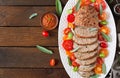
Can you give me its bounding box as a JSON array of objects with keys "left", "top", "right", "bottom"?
[{"left": 0, "top": 0, "right": 68, "bottom": 5}]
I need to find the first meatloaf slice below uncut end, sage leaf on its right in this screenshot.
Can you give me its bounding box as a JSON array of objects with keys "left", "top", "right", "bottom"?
[{"left": 74, "top": 26, "right": 98, "bottom": 38}]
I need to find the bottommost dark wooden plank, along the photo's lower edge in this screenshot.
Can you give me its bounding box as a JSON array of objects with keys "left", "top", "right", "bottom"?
[{"left": 0, "top": 69, "right": 69, "bottom": 78}]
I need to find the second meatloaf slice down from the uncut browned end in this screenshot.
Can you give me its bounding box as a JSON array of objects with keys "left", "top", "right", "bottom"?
[{"left": 73, "top": 36, "right": 98, "bottom": 45}]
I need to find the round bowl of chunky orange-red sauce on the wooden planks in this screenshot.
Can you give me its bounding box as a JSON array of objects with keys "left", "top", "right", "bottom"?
[{"left": 40, "top": 12, "right": 58, "bottom": 30}]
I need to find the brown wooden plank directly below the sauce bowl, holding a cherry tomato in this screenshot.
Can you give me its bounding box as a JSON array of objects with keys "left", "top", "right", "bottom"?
[{"left": 0, "top": 27, "right": 58, "bottom": 46}]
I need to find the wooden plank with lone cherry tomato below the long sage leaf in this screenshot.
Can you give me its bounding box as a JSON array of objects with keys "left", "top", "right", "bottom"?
[{"left": 0, "top": 47, "right": 63, "bottom": 68}]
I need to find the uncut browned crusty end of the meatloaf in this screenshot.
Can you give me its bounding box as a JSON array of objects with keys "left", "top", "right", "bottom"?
[{"left": 75, "top": 6, "right": 99, "bottom": 27}]
